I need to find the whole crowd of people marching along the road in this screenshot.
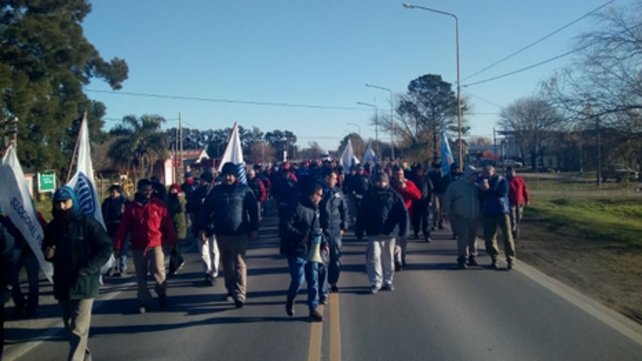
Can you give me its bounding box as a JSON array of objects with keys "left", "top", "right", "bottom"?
[{"left": 0, "top": 160, "right": 529, "bottom": 360}]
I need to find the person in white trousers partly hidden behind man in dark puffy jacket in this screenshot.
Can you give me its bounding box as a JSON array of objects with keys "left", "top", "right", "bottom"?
[{"left": 186, "top": 171, "right": 221, "bottom": 286}]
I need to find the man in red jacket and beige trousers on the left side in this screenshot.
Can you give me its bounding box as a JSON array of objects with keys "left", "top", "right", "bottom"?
[{"left": 114, "top": 179, "right": 176, "bottom": 313}]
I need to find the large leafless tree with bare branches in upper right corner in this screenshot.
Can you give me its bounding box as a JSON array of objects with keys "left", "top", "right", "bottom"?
[{"left": 543, "top": 0, "right": 642, "bottom": 168}]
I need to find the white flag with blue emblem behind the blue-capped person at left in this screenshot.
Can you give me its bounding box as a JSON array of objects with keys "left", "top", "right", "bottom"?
[{"left": 67, "top": 113, "right": 115, "bottom": 273}]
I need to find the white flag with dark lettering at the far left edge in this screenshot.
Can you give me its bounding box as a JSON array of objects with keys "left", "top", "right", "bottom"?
[{"left": 0, "top": 146, "right": 53, "bottom": 282}]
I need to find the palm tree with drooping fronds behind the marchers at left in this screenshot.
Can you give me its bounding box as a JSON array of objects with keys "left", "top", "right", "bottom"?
[{"left": 108, "top": 115, "right": 168, "bottom": 178}]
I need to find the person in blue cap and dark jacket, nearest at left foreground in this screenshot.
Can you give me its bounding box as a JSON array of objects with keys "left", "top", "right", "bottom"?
[{"left": 42, "top": 185, "right": 111, "bottom": 361}]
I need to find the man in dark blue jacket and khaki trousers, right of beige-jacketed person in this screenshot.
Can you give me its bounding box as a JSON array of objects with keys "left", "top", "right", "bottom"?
[{"left": 480, "top": 165, "right": 515, "bottom": 270}]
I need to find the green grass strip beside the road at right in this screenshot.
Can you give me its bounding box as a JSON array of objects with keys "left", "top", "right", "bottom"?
[{"left": 529, "top": 193, "right": 642, "bottom": 251}]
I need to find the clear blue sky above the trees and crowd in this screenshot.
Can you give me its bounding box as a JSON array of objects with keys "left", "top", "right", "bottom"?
[{"left": 83, "top": 0, "right": 631, "bottom": 150}]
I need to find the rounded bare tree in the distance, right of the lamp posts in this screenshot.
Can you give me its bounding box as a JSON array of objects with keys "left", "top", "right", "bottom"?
[{"left": 497, "top": 97, "right": 564, "bottom": 167}]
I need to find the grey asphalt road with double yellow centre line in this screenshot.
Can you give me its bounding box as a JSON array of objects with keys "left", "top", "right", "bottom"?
[{"left": 5, "top": 208, "right": 642, "bottom": 361}]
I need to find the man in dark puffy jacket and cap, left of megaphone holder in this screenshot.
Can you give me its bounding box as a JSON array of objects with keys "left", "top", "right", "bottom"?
[{"left": 199, "top": 162, "right": 259, "bottom": 308}]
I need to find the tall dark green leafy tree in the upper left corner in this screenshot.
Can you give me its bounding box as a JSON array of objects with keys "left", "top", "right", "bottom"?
[{"left": 0, "top": 0, "right": 128, "bottom": 169}]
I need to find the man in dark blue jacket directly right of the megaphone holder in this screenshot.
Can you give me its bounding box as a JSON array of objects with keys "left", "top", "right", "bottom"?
[{"left": 319, "top": 169, "right": 349, "bottom": 298}]
